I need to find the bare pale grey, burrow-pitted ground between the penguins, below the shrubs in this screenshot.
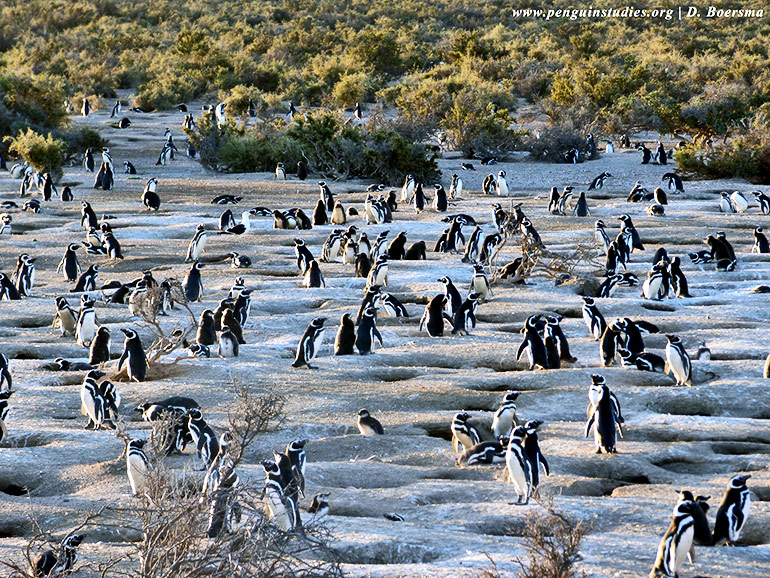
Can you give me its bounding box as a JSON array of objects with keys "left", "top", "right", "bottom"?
[{"left": 0, "top": 104, "right": 770, "bottom": 578}]
